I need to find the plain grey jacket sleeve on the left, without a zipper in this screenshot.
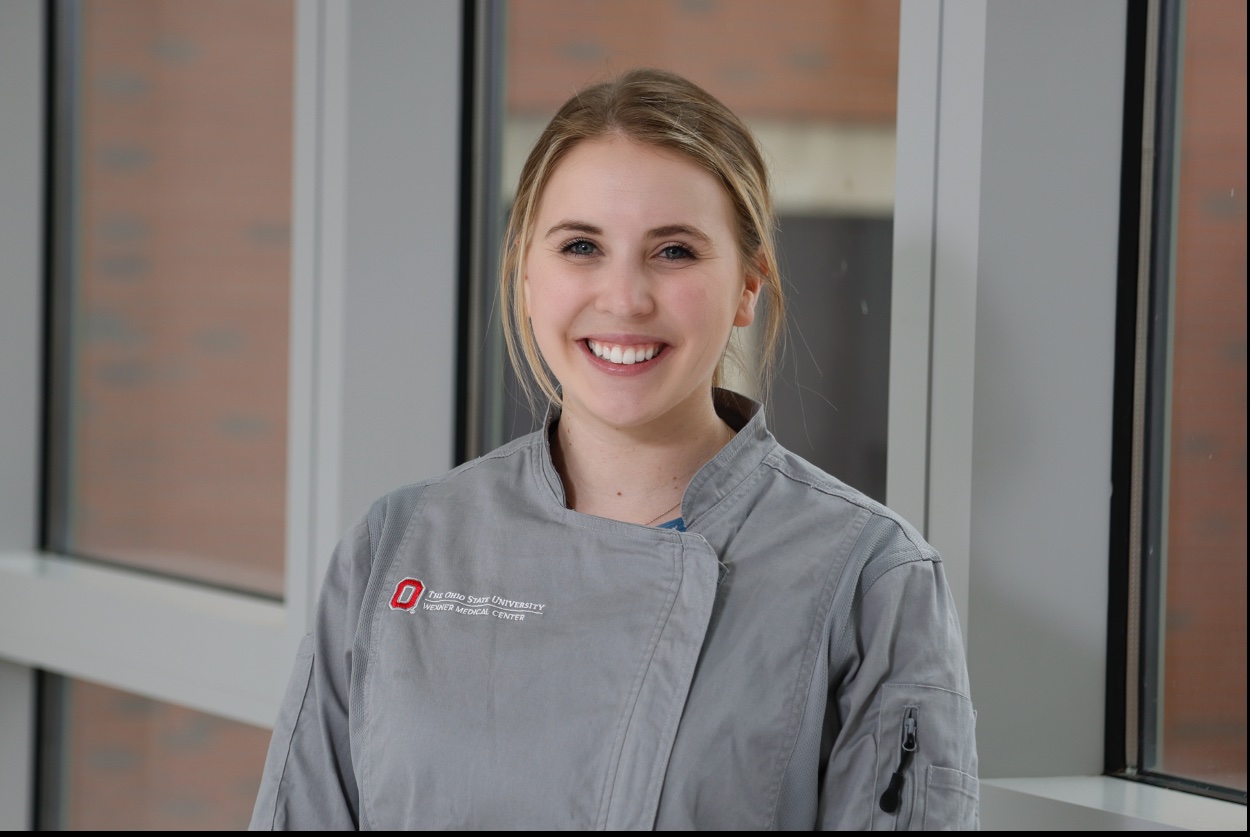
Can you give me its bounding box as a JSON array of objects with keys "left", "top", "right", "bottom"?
[{"left": 250, "top": 518, "right": 371, "bottom": 831}]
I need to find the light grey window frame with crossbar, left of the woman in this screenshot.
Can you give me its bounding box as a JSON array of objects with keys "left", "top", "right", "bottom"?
[{"left": 0, "top": 0, "right": 463, "bottom": 828}]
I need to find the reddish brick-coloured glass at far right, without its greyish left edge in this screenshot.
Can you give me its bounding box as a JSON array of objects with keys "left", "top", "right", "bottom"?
[{"left": 1146, "top": 0, "right": 1246, "bottom": 792}]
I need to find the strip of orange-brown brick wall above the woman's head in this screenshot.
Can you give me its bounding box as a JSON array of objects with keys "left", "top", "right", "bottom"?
[{"left": 506, "top": 0, "right": 899, "bottom": 125}]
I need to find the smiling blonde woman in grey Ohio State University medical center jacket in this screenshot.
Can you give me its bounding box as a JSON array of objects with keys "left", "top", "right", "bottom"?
[{"left": 253, "top": 70, "right": 978, "bottom": 828}]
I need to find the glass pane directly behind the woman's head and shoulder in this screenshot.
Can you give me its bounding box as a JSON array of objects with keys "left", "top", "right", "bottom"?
[{"left": 500, "top": 0, "right": 899, "bottom": 500}]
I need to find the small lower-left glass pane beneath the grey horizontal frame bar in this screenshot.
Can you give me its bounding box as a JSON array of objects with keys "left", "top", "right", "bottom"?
[{"left": 40, "top": 677, "right": 270, "bottom": 831}]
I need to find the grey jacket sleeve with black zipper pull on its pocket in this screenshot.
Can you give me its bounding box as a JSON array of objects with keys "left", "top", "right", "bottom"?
[{"left": 819, "top": 543, "right": 979, "bottom": 831}]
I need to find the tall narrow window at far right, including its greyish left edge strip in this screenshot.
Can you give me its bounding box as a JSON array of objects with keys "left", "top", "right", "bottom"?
[{"left": 1128, "top": 0, "right": 1246, "bottom": 802}]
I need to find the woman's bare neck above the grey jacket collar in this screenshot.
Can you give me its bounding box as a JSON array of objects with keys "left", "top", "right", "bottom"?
[{"left": 551, "top": 397, "right": 734, "bottom": 526}]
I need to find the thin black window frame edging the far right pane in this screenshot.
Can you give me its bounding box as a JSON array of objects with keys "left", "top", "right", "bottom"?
[{"left": 1125, "top": 0, "right": 1246, "bottom": 806}]
